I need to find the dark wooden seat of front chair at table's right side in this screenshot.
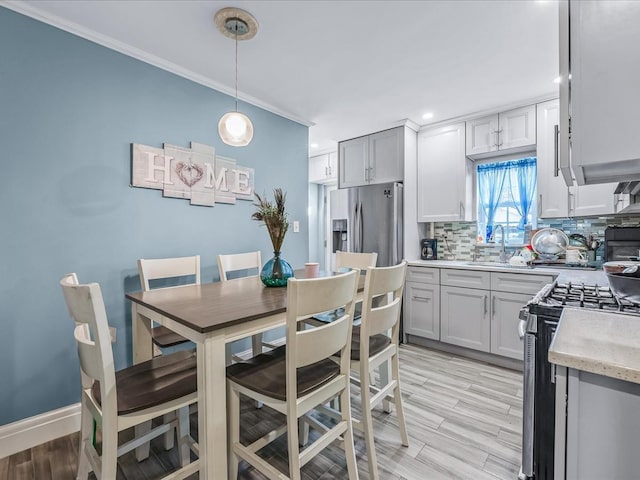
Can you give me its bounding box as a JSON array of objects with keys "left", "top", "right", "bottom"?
[{"left": 227, "top": 345, "right": 340, "bottom": 401}]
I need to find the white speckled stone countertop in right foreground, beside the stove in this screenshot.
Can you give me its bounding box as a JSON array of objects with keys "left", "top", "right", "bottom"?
[{"left": 549, "top": 308, "right": 640, "bottom": 383}]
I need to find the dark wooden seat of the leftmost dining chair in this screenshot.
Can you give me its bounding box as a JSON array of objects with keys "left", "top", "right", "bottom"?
[{"left": 91, "top": 351, "right": 198, "bottom": 415}]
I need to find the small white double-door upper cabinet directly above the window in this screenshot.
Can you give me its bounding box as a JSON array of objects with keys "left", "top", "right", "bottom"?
[{"left": 466, "top": 105, "right": 536, "bottom": 158}]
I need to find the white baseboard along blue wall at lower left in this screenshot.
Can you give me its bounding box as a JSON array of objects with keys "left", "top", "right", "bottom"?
[{"left": 0, "top": 403, "right": 80, "bottom": 458}]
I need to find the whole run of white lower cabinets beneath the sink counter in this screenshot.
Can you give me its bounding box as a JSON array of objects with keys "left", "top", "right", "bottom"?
[{"left": 404, "top": 266, "right": 554, "bottom": 360}]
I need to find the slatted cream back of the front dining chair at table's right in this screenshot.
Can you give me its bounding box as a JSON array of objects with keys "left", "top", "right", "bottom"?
[{"left": 287, "top": 269, "right": 359, "bottom": 368}]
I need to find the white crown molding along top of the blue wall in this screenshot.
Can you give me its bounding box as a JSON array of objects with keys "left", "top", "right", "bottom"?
[{"left": 0, "top": 0, "right": 315, "bottom": 127}]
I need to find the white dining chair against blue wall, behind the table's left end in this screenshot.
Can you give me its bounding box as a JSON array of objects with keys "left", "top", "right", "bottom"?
[{"left": 138, "top": 255, "right": 200, "bottom": 355}]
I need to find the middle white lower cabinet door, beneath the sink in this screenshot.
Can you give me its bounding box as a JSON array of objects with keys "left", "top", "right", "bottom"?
[{"left": 440, "top": 286, "right": 491, "bottom": 352}]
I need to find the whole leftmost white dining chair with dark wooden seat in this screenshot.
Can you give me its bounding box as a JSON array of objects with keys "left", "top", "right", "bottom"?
[{"left": 60, "top": 273, "right": 199, "bottom": 480}]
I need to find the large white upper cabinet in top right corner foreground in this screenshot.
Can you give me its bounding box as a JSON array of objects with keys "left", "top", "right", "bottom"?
[{"left": 560, "top": 0, "right": 640, "bottom": 185}]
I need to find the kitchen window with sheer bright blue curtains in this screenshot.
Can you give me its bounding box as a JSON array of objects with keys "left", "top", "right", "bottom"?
[{"left": 476, "top": 157, "right": 537, "bottom": 245}]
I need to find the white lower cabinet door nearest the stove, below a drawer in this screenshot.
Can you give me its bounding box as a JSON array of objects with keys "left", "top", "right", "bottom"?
[{"left": 491, "top": 292, "right": 531, "bottom": 360}]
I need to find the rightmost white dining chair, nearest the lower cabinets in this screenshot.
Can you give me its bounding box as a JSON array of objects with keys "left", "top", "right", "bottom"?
[{"left": 332, "top": 261, "right": 409, "bottom": 479}]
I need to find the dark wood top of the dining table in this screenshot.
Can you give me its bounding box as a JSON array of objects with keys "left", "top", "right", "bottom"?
[{"left": 126, "top": 270, "right": 364, "bottom": 333}]
